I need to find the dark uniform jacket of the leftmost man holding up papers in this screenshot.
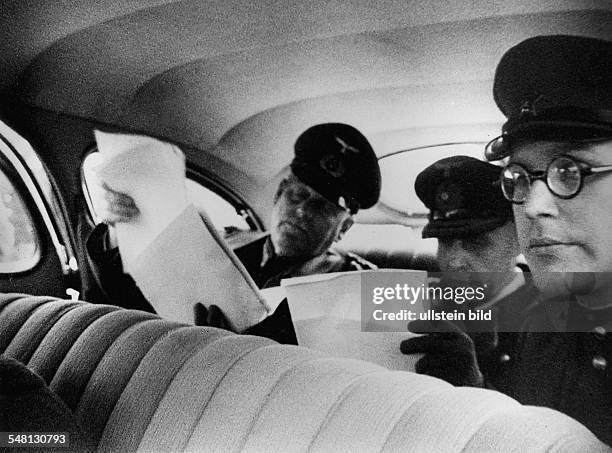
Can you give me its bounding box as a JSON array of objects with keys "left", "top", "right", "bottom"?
[{"left": 85, "top": 224, "right": 376, "bottom": 344}]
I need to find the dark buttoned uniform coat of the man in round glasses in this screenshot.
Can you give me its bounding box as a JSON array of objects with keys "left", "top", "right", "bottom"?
[{"left": 430, "top": 274, "right": 612, "bottom": 446}]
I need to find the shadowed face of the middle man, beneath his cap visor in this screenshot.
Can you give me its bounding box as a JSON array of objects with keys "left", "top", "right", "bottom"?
[{"left": 437, "top": 221, "right": 518, "bottom": 294}]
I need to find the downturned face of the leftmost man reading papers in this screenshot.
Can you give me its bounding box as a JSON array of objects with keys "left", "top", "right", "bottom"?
[{"left": 270, "top": 178, "right": 352, "bottom": 257}]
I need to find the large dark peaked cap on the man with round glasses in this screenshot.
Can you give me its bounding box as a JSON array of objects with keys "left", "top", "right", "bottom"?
[{"left": 487, "top": 35, "right": 612, "bottom": 160}]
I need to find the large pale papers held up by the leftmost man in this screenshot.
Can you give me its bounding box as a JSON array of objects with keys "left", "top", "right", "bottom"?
[{"left": 96, "top": 131, "right": 267, "bottom": 331}]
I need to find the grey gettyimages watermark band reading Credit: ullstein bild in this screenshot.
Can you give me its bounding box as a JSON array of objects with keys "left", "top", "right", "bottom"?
[{"left": 361, "top": 270, "right": 612, "bottom": 332}]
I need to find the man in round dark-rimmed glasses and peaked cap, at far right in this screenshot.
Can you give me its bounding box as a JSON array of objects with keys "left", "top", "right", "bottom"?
[{"left": 487, "top": 36, "right": 612, "bottom": 445}]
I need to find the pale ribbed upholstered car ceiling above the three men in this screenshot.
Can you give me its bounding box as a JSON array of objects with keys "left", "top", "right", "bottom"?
[{"left": 0, "top": 0, "right": 612, "bottom": 214}]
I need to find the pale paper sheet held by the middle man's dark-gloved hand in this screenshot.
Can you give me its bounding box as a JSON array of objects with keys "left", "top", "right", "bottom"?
[{"left": 281, "top": 271, "right": 427, "bottom": 371}]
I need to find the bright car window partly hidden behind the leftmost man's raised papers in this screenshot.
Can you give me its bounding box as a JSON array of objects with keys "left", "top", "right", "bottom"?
[{"left": 82, "top": 151, "right": 251, "bottom": 236}]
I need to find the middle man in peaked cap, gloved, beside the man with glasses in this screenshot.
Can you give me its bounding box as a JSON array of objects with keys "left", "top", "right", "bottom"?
[{"left": 401, "top": 156, "right": 535, "bottom": 387}]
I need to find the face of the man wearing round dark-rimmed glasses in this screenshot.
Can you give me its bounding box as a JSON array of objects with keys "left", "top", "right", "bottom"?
[{"left": 511, "top": 141, "right": 612, "bottom": 283}]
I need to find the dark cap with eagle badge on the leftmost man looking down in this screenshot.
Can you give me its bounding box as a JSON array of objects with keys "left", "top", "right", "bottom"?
[{"left": 291, "top": 123, "right": 380, "bottom": 213}]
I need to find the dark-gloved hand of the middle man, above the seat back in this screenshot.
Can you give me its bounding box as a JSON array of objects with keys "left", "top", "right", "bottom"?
[{"left": 400, "top": 321, "right": 494, "bottom": 387}]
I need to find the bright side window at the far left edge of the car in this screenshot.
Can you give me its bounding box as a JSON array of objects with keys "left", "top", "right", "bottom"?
[{"left": 0, "top": 167, "right": 41, "bottom": 274}]
